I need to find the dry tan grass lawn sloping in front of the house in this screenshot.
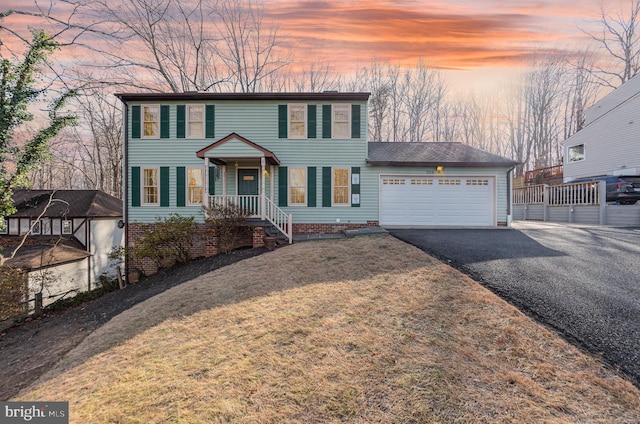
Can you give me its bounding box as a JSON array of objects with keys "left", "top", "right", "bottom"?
[{"left": 17, "top": 235, "right": 640, "bottom": 423}]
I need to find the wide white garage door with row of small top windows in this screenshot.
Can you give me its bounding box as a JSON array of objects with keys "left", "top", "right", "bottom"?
[{"left": 380, "top": 175, "right": 496, "bottom": 226}]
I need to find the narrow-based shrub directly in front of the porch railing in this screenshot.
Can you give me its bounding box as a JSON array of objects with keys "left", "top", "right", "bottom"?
[{"left": 204, "top": 203, "right": 251, "bottom": 253}]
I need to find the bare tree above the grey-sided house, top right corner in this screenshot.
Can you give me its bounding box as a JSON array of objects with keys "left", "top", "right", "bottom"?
[{"left": 584, "top": 0, "right": 640, "bottom": 88}]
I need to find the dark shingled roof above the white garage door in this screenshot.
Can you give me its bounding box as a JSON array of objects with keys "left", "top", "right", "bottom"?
[{"left": 367, "top": 142, "right": 519, "bottom": 167}]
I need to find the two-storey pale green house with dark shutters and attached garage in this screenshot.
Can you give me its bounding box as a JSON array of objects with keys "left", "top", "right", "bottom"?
[{"left": 117, "top": 92, "right": 516, "bottom": 255}]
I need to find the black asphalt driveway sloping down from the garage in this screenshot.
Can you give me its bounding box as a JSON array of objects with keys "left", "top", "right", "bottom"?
[{"left": 390, "top": 221, "right": 640, "bottom": 387}]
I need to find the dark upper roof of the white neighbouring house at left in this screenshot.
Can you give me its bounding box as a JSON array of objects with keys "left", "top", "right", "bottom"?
[{"left": 7, "top": 190, "right": 122, "bottom": 218}]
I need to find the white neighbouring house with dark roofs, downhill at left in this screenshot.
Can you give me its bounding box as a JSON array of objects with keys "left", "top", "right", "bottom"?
[{"left": 0, "top": 190, "right": 124, "bottom": 306}]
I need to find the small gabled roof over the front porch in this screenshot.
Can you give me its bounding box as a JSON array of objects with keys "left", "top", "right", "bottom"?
[{"left": 196, "top": 133, "right": 280, "bottom": 165}]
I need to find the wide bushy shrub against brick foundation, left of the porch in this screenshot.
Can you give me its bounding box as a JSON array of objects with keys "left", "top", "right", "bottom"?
[{"left": 133, "top": 214, "right": 195, "bottom": 268}]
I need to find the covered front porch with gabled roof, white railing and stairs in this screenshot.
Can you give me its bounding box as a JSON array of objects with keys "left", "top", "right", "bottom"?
[{"left": 196, "top": 133, "right": 293, "bottom": 243}]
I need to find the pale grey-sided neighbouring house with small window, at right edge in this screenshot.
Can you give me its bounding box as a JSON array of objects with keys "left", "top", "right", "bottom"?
[{"left": 564, "top": 75, "right": 640, "bottom": 182}]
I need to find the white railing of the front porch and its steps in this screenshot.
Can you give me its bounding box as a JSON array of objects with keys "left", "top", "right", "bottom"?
[{"left": 209, "top": 194, "right": 293, "bottom": 243}]
